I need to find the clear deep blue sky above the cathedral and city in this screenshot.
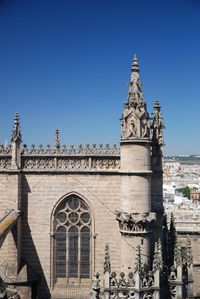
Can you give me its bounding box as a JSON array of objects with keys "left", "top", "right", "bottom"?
[{"left": 0, "top": 0, "right": 200, "bottom": 154}]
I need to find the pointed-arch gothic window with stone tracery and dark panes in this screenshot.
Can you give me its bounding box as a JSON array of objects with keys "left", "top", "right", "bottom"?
[{"left": 54, "top": 195, "right": 91, "bottom": 281}]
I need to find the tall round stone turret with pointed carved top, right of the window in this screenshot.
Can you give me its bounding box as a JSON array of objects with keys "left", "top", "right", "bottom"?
[{"left": 117, "top": 55, "right": 155, "bottom": 271}]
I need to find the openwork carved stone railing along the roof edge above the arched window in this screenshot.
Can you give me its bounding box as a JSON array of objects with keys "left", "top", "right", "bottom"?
[{"left": 0, "top": 144, "right": 120, "bottom": 172}]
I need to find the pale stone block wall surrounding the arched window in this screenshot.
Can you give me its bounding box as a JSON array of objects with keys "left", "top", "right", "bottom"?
[{"left": 19, "top": 174, "right": 121, "bottom": 293}]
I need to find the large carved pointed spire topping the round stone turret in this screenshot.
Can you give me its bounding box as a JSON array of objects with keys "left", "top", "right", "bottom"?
[{"left": 121, "top": 55, "right": 150, "bottom": 140}]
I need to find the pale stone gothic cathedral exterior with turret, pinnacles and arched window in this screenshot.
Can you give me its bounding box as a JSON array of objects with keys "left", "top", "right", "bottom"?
[{"left": 0, "top": 56, "right": 193, "bottom": 299}]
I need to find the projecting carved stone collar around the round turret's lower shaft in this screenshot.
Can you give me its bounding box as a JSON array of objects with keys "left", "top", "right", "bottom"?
[{"left": 116, "top": 211, "right": 156, "bottom": 235}]
